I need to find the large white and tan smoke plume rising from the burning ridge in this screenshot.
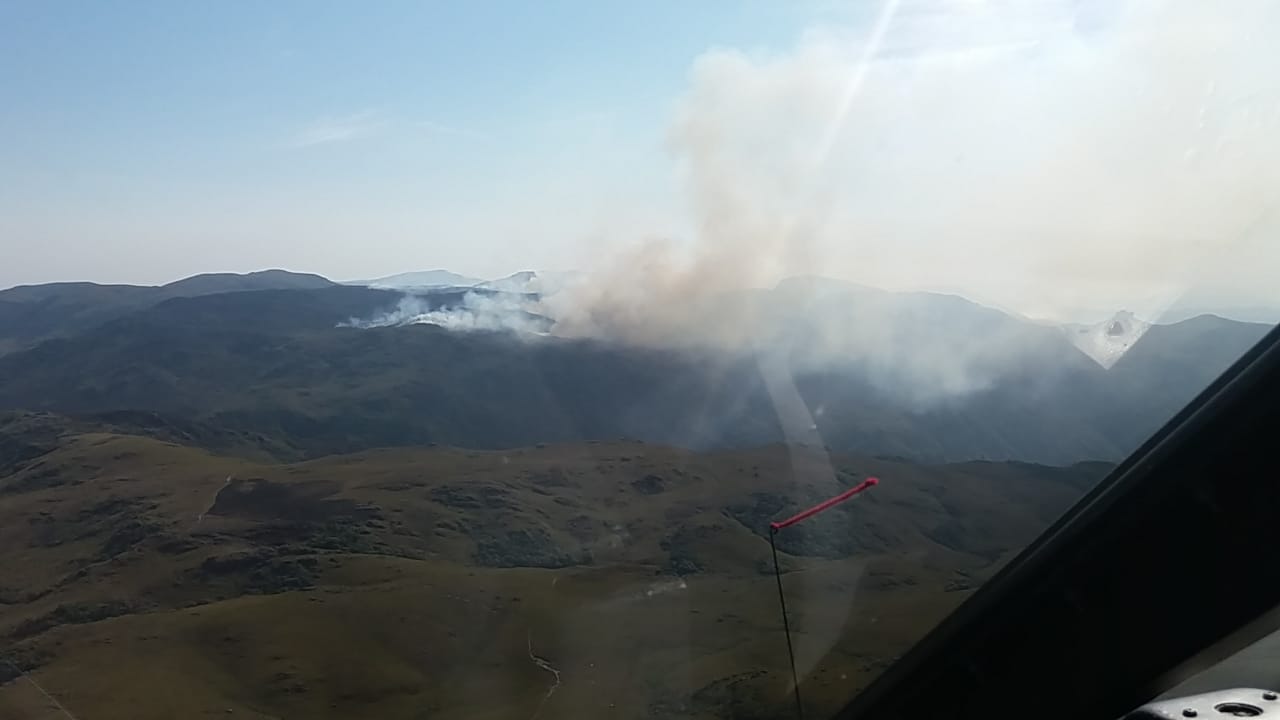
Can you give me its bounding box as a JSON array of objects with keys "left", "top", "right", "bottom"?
[{"left": 345, "top": 0, "right": 1280, "bottom": 396}]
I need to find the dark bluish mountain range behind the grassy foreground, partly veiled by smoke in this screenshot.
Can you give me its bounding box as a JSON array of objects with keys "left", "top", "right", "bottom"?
[{"left": 0, "top": 270, "right": 1268, "bottom": 464}]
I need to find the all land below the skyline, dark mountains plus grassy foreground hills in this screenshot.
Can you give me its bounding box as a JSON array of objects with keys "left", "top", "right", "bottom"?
[{"left": 0, "top": 270, "right": 1268, "bottom": 720}]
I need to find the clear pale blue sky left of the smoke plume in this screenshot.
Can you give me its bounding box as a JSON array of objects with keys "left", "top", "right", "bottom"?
[{"left": 0, "top": 1, "right": 860, "bottom": 286}]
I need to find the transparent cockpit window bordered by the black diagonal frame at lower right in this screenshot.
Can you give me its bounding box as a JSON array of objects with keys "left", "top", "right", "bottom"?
[{"left": 0, "top": 0, "right": 1280, "bottom": 720}]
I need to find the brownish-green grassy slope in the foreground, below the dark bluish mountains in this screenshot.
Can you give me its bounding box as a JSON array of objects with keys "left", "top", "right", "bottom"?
[{"left": 0, "top": 434, "right": 1100, "bottom": 719}]
